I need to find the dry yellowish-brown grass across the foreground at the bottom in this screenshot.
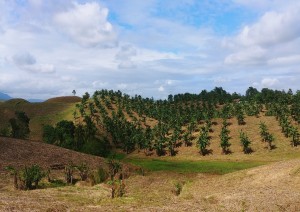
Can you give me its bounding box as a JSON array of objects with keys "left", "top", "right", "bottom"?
[{"left": 0, "top": 159, "right": 300, "bottom": 211}]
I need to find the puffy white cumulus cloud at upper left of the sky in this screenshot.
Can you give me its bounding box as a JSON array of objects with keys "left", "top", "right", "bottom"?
[{"left": 54, "top": 2, "right": 116, "bottom": 47}]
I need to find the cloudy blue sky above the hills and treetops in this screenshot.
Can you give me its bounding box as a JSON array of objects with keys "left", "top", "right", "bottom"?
[{"left": 0, "top": 0, "right": 300, "bottom": 99}]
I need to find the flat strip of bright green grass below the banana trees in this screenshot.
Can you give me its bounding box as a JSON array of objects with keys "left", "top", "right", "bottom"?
[{"left": 124, "top": 158, "right": 265, "bottom": 174}]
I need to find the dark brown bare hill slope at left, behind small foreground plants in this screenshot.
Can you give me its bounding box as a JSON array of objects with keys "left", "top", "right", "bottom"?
[{"left": 0, "top": 137, "right": 104, "bottom": 171}]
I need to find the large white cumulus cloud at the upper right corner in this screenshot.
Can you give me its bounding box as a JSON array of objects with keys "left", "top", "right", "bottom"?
[{"left": 223, "top": 0, "right": 300, "bottom": 66}]
